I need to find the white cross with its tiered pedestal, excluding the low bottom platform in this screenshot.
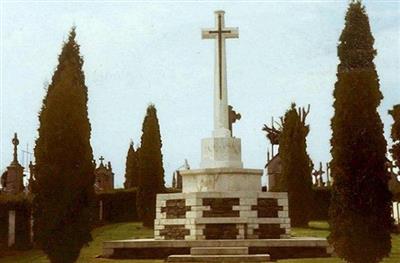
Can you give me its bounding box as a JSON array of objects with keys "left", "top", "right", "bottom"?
[{"left": 155, "top": 11, "right": 290, "bottom": 245}]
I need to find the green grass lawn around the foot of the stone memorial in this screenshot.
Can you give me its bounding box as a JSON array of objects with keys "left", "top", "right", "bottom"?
[{"left": 0, "top": 222, "right": 400, "bottom": 263}]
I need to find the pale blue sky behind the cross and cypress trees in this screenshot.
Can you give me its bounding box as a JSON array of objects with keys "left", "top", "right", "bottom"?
[{"left": 0, "top": 1, "right": 400, "bottom": 187}]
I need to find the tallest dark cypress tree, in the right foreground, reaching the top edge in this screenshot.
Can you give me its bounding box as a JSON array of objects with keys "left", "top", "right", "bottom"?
[{"left": 328, "top": 1, "right": 391, "bottom": 263}]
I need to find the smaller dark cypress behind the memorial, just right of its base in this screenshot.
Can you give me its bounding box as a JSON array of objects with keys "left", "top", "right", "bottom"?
[{"left": 276, "top": 103, "right": 312, "bottom": 226}]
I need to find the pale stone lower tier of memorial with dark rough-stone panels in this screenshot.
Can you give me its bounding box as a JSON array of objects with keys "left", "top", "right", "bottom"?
[{"left": 154, "top": 192, "right": 290, "bottom": 240}]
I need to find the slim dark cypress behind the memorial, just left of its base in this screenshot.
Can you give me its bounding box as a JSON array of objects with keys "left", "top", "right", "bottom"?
[{"left": 136, "top": 104, "right": 164, "bottom": 227}]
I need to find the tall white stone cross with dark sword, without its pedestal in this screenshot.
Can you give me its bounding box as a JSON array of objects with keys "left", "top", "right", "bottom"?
[{"left": 202, "top": 11, "right": 239, "bottom": 137}]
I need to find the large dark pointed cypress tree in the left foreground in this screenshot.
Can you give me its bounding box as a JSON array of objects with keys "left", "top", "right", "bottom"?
[{"left": 32, "top": 28, "right": 94, "bottom": 262}]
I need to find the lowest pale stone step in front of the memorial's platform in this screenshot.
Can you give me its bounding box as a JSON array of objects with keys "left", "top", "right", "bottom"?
[{"left": 167, "top": 254, "right": 270, "bottom": 263}]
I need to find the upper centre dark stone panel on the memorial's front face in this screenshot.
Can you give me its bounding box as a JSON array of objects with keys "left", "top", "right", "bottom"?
[{"left": 203, "top": 198, "right": 240, "bottom": 217}]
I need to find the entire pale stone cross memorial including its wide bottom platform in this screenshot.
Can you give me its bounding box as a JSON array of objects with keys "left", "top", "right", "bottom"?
[{"left": 103, "top": 11, "right": 327, "bottom": 262}]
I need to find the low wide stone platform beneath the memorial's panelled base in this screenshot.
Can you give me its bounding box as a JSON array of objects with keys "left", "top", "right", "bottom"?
[{"left": 103, "top": 237, "right": 333, "bottom": 260}]
